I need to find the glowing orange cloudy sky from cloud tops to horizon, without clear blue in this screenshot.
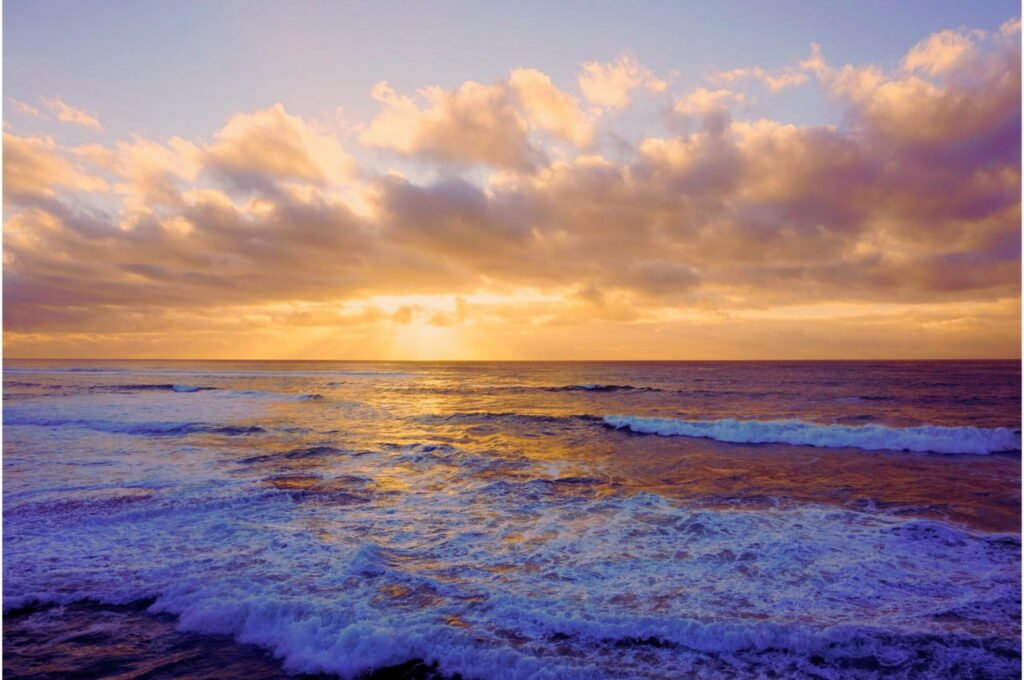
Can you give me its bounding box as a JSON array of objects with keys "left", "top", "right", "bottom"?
[{"left": 3, "top": 11, "right": 1021, "bottom": 359}]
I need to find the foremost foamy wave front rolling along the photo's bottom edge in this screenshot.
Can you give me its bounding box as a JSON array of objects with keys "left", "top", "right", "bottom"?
[{"left": 4, "top": 536, "right": 1020, "bottom": 679}]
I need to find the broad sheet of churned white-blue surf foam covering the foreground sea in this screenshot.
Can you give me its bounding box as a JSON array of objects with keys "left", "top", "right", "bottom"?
[{"left": 4, "top": 471, "right": 1020, "bottom": 679}]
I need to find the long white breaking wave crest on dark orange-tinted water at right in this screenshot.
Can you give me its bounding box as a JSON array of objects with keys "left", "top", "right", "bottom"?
[{"left": 604, "top": 416, "right": 1021, "bottom": 455}]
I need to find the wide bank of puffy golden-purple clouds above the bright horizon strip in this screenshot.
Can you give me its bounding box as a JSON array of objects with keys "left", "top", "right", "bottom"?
[{"left": 4, "top": 22, "right": 1021, "bottom": 358}]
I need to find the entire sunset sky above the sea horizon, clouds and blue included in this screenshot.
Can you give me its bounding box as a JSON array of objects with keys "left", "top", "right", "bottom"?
[{"left": 3, "top": 0, "right": 1021, "bottom": 359}]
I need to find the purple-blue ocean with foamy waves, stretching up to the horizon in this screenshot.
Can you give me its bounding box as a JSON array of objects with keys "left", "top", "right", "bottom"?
[{"left": 3, "top": 360, "right": 1021, "bottom": 680}]
